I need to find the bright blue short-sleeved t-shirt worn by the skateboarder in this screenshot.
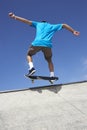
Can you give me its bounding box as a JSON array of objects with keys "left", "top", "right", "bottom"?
[{"left": 31, "top": 21, "right": 62, "bottom": 48}]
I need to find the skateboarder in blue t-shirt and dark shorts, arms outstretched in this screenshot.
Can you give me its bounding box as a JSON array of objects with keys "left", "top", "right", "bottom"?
[{"left": 9, "top": 13, "right": 80, "bottom": 77}]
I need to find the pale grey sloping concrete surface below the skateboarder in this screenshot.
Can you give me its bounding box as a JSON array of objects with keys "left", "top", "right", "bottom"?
[{"left": 0, "top": 82, "right": 87, "bottom": 130}]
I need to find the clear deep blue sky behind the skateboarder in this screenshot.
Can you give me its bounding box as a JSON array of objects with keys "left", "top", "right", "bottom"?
[{"left": 0, "top": 0, "right": 87, "bottom": 91}]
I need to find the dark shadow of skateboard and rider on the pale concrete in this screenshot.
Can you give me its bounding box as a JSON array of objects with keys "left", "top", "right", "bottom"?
[{"left": 30, "top": 84, "right": 62, "bottom": 93}]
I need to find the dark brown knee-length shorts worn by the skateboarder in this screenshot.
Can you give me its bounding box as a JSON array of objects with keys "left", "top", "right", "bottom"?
[{"left": 27, "top": 46, "right": 52, "bottom": 58}]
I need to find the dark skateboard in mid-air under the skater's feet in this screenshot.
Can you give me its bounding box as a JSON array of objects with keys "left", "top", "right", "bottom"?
[{"left": 25, "top": 75, "right": 59, "bottom": 84}]
